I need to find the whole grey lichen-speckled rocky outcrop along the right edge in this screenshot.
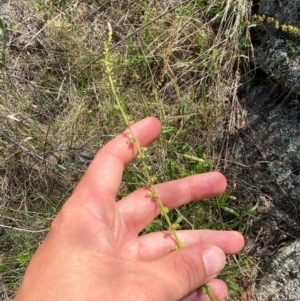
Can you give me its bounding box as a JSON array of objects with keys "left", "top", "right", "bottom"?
[{"left": 251, "top": 5, "right": 300, "bottom": 301}]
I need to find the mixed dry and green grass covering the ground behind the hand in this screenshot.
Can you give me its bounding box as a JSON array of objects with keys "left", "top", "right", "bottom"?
[{"left": 0, "top": 0, "right": 253, "bottom": 300}]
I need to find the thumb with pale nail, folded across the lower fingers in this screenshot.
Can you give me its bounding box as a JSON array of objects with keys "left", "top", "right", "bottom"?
[{"left": 155, "top": 244, "right": 226, "bottom": 300}]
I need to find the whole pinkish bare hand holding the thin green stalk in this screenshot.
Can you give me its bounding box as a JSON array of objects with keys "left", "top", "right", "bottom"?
[{"left": 15, "top": 117, "right": 244, "bottom": 301}]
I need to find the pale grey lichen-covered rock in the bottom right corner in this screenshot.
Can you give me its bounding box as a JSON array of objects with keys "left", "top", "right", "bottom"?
[{"left": 256, "top": 240, "right": 300, "bottom": 301}]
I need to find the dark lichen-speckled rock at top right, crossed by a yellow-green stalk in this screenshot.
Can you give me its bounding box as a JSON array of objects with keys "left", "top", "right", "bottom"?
[{"left": 253, "top": 0, "right": 300, "bottom": 95}]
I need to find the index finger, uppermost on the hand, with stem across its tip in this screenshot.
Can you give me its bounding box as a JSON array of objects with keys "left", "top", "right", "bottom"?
[{"left": 73, "top": 117, "right": 161, "bottom": 210}]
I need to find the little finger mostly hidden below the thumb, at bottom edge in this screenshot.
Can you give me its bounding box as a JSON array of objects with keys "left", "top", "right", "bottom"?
[{"left": 180, "top": 279, "right": 227, "bottom": 301}]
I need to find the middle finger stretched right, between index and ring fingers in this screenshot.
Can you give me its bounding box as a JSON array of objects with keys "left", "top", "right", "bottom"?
[{"left": 118, "top": 172, "right": 226, "bottom": 234}]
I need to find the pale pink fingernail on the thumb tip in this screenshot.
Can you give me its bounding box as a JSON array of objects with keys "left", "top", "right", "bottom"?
[{"left": 202, "top": 247, "right": 225, "bottom": 277}]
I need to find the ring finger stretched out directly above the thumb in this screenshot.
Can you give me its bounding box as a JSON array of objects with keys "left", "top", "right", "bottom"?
[{"left": 138, "top": 230, "right": 244, "bottom": 261}]
